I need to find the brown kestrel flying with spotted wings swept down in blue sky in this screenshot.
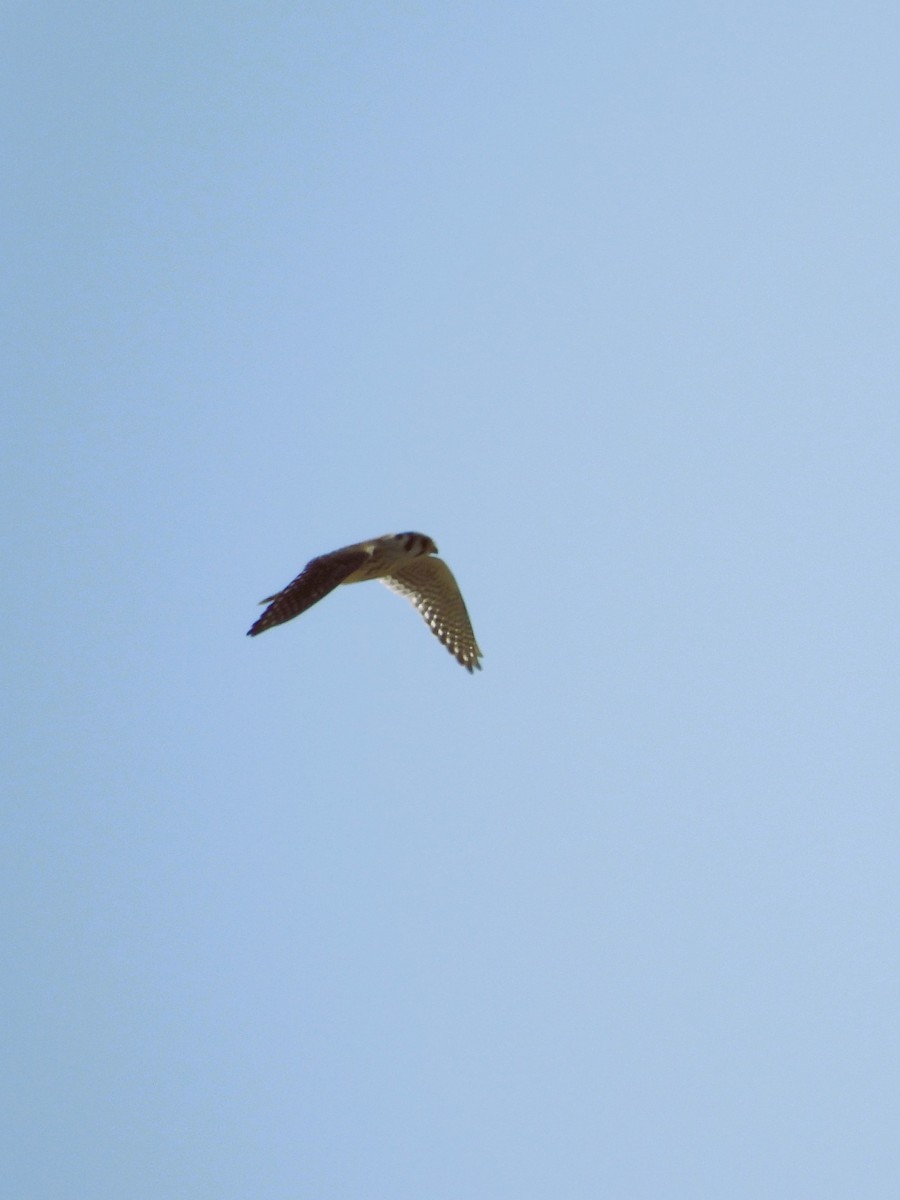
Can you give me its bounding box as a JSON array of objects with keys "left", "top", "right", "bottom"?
[{"left": 247, "top": 533, "right": 481, "bottom": 673}]
